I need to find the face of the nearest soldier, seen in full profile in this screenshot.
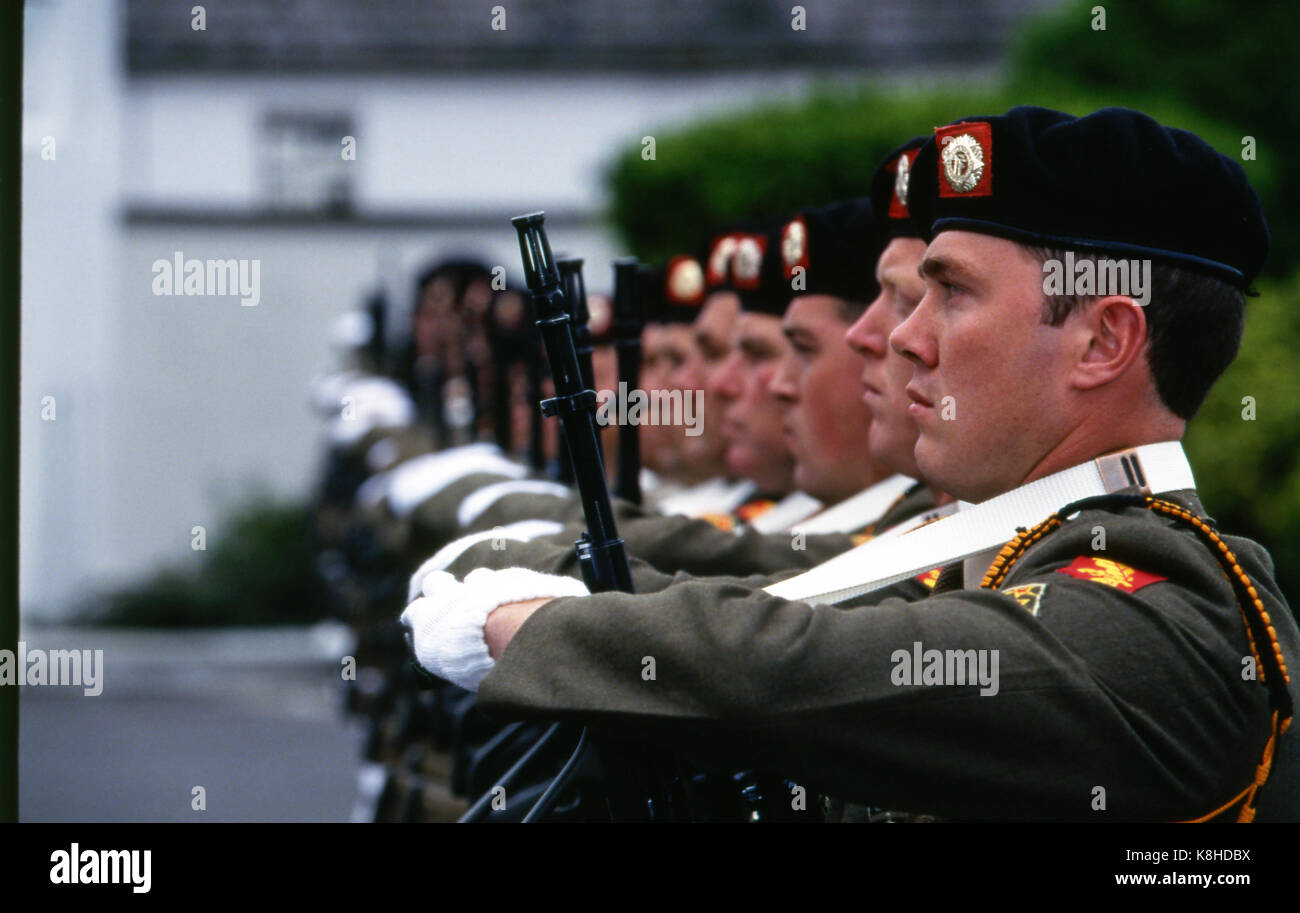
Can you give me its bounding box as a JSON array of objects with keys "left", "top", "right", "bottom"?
[{"left": 889, "top": 232, "right": 1073, "bottom": 502}]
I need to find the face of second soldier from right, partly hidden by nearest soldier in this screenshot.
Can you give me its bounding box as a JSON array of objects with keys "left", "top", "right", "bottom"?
[{"left": 845, "top": 238, "right": 926, "bottom": 479}]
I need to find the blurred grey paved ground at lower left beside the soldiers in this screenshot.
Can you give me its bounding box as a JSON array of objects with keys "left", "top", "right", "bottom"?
[{"left": 18, "top": 628, "right": 359, "bottom": 822}]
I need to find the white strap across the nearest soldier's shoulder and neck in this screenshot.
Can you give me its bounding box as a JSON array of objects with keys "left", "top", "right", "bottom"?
[{"left": 767, "top": 441, "right": 1196, "bottom": 603}]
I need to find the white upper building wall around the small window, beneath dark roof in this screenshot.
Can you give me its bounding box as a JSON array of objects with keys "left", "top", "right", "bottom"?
[{"left": 124, "top": 73, "right": 832, "bottom": 211}]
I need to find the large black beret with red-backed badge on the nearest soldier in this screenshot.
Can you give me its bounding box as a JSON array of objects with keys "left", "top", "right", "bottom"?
[{"left": 907, "top": 107, "right": 1269, "bottom": 287}]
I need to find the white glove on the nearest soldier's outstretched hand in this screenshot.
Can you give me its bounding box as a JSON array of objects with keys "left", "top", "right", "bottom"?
[{"left": 402, "top": 567, "right": 589, "bottom": 691}]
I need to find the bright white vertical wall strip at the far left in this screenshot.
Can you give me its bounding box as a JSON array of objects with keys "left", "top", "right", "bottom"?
[{"left": 18, "top": 0, "right": 130, "bottom": 614}]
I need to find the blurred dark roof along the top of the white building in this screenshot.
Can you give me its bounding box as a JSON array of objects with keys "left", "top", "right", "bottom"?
[{"left": 125, "top": 0, "right": 1057, "bottom": 75}]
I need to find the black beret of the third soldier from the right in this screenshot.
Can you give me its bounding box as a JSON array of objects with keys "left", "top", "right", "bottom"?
[{"left": 780, "top": 196, "right": 888, "bottom": 303}]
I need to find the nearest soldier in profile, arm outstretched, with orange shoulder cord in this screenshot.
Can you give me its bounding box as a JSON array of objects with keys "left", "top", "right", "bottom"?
[{"left": 407, "top": 108, "right": 1300, "bottom": 821}]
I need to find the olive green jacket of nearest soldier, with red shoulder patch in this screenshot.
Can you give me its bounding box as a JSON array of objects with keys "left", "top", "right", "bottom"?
[{"left": 478, "top": 492, "right": 1300, "bottom": 821}]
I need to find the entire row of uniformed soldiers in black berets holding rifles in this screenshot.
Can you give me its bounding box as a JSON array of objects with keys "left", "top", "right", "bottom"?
[{"left": 322, "top": 108, "right": 1300, "bottom": 821}]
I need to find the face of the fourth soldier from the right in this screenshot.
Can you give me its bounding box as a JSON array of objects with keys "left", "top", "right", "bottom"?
[{"left": 706, "top": 312, "right": 794, "bottom": 492}]
